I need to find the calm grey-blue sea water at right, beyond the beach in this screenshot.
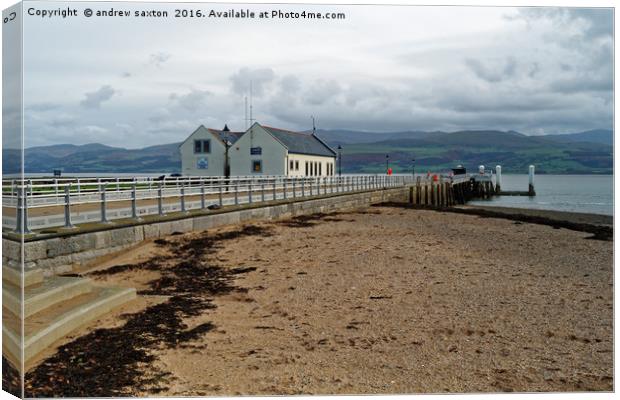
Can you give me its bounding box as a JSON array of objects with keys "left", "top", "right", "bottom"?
[{"left": 468, "top": 174, "right": 614, "bottom": 215}]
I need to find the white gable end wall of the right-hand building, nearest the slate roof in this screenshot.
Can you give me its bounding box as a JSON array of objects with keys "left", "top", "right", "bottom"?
[{"left": 229, "top": 124, "right": 287, "bottom": 175}]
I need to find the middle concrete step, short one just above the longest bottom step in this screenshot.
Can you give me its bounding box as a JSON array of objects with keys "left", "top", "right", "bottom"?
[{"left": 2, "top": 276, "right": 92, "bottom": 318}]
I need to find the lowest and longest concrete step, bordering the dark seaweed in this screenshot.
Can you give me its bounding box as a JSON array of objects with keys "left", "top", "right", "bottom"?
[{"left": 2, "top": 286, "right": 136, "bottom": 371}]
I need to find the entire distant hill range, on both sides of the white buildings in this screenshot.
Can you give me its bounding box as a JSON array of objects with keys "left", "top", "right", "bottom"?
[{"left": 3, "top": 130, "right": 613, "bottom": 174}]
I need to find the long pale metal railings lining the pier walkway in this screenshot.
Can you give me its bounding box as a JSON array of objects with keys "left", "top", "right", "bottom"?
[{"left": 2, "top": 175, "right": 416, "bottom": 233}]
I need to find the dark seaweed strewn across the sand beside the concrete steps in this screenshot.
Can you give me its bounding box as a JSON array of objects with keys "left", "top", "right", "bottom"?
[{"left": 24, "top": 226, "right": 270, "bottom": 397}]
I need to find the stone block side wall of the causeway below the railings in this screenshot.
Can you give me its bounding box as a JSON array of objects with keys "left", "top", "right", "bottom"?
[{"left": 7, "top": 186, "right": 412, "bottom": 275}]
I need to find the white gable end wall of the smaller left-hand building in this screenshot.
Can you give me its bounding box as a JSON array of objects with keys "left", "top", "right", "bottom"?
[{"left": 179, "top": 125, "right": 226, "bottom": 176}]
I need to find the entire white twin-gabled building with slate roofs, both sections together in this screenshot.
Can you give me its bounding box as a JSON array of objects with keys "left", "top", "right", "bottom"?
[{"left": 180, "top": 122, "right": 336, "bottom": 176}]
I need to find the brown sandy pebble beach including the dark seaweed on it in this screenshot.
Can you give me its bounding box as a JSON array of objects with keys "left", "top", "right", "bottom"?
[{"left": 20, "top": 206, "right": 613, "bottom": 396}]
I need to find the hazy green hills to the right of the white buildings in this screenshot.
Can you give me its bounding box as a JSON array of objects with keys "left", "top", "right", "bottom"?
[{"left": 318, "top": 130, "right": 613, "bottom": 174}]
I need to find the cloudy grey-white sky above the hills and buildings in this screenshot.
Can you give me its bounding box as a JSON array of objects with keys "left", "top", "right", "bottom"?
[{"left": 15, "top": 2, "right": 613, "bottom": 148}]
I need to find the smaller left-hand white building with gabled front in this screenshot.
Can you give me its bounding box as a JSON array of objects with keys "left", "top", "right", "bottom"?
[{"left": 179, "top": 125, "right": 243, "bottom": 176}]
